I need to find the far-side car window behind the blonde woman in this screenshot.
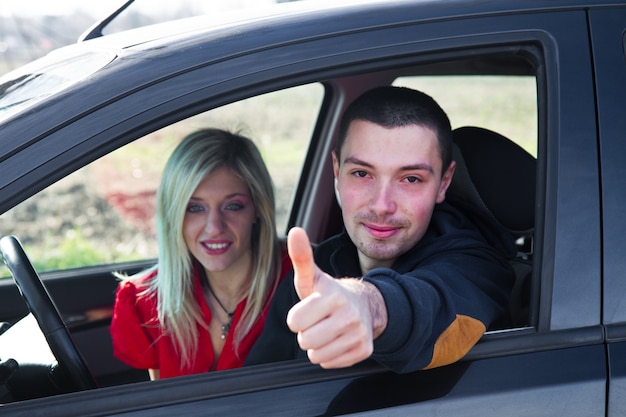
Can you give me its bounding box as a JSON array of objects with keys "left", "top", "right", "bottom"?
[{"left": 0, "top": 84, "right": 323, "bottom": 277}]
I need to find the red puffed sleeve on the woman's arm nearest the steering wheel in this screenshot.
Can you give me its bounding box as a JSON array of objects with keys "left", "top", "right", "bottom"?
[{"left": 110, "top": 282, "right": 159, "bottom": 369}]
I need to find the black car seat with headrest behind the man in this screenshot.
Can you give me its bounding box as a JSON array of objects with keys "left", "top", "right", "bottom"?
[{"left": 448, "top": 126, "right": 537, "bottom": 326}]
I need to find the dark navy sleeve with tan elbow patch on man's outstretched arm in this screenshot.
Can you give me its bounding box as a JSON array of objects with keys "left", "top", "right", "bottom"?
[{"left": 364, "top": 218, "right": 514, "bottom": 372}]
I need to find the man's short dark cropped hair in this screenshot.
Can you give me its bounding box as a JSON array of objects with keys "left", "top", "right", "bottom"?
[{"left": 335, "top": 86, "right": 452, "bottom": 175}]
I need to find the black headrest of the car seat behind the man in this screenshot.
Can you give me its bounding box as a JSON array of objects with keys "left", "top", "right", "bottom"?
[{"left": 448, "top": 126, "right": 537, "bottom": 235}]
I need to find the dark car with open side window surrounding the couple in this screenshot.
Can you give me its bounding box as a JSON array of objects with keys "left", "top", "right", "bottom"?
[{"left": 0, "top": 0, "right": 626, "bottom": 417}]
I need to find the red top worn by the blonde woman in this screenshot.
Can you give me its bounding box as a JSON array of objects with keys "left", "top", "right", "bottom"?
[{"left": 110, "top": 252, "right": 291, "bottom": 378}]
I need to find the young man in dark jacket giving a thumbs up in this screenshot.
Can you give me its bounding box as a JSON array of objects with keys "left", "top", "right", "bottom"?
[{"left": 246, "top": 87, "right": 515, "bottom": 372}]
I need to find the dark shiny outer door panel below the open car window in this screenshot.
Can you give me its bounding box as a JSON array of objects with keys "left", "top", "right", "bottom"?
[{"left": 1, "top": 345, "right": 606, "bottom": 417}]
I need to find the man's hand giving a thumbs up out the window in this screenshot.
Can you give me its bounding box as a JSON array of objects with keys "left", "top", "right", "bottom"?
[{"left": 287, "top": 228, "right": 387, "bottom": 368}]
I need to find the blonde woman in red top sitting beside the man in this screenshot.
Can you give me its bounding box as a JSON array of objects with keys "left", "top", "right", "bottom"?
[{"left": 111, "top": 129, "right": 291, "bottom": 379}]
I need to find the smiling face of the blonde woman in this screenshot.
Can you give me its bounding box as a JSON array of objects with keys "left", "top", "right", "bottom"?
[{"left": 183, "top": 167, "right": 256, "bottom": 276}]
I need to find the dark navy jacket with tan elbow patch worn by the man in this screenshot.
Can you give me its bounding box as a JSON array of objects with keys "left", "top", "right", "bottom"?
[{"left": 246, "top": 202, "right": 515, "bottom": 373}]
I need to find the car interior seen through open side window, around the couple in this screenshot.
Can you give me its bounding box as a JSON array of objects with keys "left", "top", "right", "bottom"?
[{"left": 0, "top": 47, "right": 540, "bottom": 402}]
